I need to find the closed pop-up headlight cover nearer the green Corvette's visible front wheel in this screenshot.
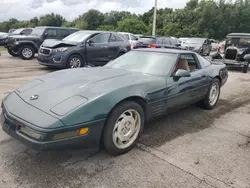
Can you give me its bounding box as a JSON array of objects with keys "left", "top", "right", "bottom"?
[{"left": 50, "top": 95, "right": 88, "bottom": 116}]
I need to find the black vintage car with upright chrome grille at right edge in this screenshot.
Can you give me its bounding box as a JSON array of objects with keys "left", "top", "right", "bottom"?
[{"left": 214, "top": 33, "right": 250, "bottom": 73}]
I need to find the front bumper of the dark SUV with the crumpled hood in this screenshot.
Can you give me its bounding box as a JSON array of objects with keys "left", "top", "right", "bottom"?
[{"left": 37, "top": 53, "right": 67, "bottom": 68}]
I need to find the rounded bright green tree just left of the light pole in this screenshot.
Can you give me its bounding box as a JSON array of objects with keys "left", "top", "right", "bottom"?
[{"left": 117, "top": 18, "right": 148, "bottom": 34}]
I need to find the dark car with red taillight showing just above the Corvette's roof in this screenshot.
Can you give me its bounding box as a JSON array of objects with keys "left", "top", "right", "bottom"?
[{"left": 136, "top": 36, "right": 181, "bottom": 49}]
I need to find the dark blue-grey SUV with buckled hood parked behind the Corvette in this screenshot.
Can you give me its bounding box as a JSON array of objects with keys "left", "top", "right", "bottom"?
[{"left": 38, "top": 31, "right": 131, "bottom": 68}]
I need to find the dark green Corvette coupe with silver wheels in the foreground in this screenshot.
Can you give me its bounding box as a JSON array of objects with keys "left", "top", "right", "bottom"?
[{"left": 1, "top": 49, "right": 228, "bottom": 155}]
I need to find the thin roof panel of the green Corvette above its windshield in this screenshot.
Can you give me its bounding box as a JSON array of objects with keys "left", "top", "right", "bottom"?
[{"left": 133, "top": 48, "right": 192, "bottom": 54}]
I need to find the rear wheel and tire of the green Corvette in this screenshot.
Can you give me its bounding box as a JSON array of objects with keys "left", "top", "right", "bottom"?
[{"left": 201, "top": 78, "right": 221, "bottom": 110}]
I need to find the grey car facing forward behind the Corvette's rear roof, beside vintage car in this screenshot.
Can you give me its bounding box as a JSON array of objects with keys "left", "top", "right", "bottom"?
[{"left": 183, "top": 38, "right": 212, "bottom": 56}]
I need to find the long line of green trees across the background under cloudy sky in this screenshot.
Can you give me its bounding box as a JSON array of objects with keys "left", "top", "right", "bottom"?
[{"left": 0, "top": 0, "right": 250, "bottom": 39}]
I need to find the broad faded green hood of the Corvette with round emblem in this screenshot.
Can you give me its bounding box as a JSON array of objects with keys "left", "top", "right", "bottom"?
[{"left": 15, "top": 67, "right": 157, "bottom": 117}]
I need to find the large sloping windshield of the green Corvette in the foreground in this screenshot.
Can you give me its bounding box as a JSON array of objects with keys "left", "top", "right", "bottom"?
[{"left": 105, "top": 51, "right": 178, "bottom": 75}]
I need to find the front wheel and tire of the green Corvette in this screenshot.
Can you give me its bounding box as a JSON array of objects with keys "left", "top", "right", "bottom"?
[{"left": 102, "top": 101, "right": 145, "bottom": 156}]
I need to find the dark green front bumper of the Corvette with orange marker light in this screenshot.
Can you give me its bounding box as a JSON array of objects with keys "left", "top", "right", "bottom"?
[{"left": 0, "top": 97, "right": 105, "bottom": 150}]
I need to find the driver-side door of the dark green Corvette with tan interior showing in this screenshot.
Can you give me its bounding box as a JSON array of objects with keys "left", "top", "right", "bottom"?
[{"left": 167, "top": 53, "right": 208, "bottom": 112}]
